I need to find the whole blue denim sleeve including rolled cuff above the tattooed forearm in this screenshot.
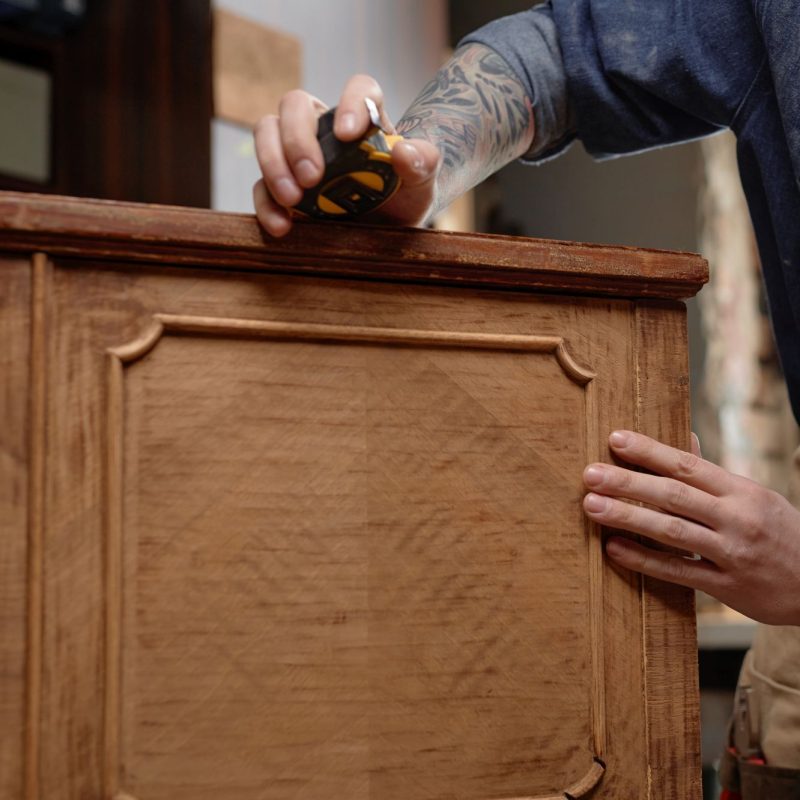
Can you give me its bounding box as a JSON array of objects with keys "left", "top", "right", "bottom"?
[{"left": 464, "top": 0, "right": 764, "bottom": 160}]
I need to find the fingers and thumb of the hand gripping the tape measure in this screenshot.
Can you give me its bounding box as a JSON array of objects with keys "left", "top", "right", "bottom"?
[{"left": 253, "top": 75, "right": 440, "bottom": 236}]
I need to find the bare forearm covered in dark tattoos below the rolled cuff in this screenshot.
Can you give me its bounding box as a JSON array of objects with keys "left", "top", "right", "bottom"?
[{"left": 397, "top": 44, "right": 533, "bottom": 217}]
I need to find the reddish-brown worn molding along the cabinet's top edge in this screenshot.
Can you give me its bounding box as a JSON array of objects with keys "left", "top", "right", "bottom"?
[{"left": 0, "top": 192, "right": 708, "bottom": 300}]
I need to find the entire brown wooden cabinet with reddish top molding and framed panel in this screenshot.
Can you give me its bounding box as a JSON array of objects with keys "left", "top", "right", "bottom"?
[{"left": 0, "top": 194, "right": 706, "bottom": 800}]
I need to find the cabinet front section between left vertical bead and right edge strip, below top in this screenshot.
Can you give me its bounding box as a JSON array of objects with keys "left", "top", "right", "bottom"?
[{"left": 32, "top": 262, "right": 664, "bottom": 800}]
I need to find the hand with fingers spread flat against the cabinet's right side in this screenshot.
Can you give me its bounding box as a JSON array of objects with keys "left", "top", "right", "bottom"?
[{"left": 583, "top": 431, "right": 800, "bottom": 625}]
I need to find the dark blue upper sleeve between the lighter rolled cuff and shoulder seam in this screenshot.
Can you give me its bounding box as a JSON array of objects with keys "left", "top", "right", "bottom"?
[{"left": 553, "top": 0, "right": 764, "bottom": 157}]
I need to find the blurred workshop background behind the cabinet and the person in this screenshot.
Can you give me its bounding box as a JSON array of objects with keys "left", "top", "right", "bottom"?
[{"left": 0, "top": 0, "right": 798, "bottom": 796}]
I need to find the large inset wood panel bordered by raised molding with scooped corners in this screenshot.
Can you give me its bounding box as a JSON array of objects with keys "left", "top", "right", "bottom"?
[{"left": 109, "top": 323, "right": 604, "bottom": 800}]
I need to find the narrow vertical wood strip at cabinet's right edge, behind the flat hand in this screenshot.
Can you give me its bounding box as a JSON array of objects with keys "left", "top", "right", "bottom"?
[{"left": 635, "top": 302, "right": 701, "bottom": 800}]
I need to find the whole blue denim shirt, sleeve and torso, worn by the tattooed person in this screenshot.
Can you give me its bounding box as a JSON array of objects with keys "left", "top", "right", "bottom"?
[{"left": 465, "top": 0, "right": 800, "bottom": 422}]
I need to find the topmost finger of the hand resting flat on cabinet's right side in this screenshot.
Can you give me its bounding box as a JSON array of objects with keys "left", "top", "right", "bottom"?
[{"left": 608, "top": 431, "right": 733, "bottom": 497}]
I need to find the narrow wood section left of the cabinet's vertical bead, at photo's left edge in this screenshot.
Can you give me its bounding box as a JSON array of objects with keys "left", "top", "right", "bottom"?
[{"left": 0, "top": 259, "right": 31, "bottom": 800}]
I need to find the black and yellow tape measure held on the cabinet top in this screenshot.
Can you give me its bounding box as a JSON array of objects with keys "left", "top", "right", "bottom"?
[{"left": 292, "top": 98, "right": 403, "bottom": 220}]
